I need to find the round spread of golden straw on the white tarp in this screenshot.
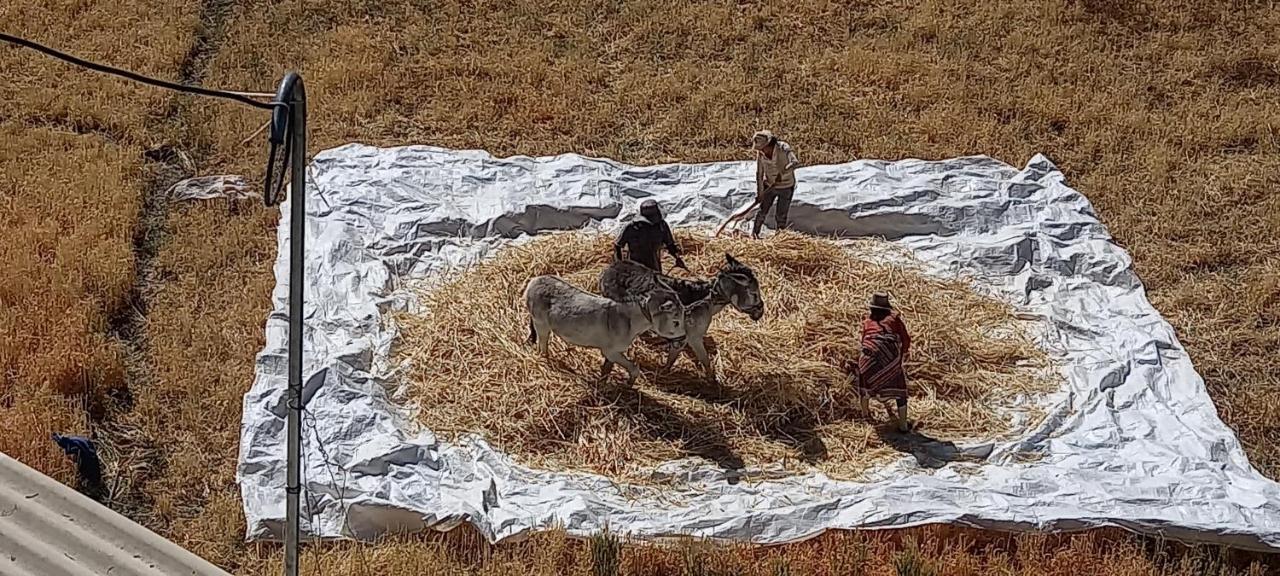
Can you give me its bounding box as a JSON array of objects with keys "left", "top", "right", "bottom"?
[{"left": 399, "top": 232, "right": 1053, "bottom": 481}]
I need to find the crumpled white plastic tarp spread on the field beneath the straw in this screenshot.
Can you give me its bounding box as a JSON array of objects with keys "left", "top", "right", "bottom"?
[{"left": 238, "top": 145, "right": 1280, "bottom": 549}]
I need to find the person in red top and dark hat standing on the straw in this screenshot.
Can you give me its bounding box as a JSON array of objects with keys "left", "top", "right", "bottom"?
[{"left": 854, "top": 294, "right": 911, "bottom": 431}]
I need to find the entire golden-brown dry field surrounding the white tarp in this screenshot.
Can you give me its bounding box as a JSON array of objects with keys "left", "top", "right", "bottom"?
[{"left": 0, "top": 0, "right": 1280, "bottom": 575}]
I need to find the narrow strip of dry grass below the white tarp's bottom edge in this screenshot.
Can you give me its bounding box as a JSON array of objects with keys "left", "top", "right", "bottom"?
[{"left": 220, "top": 526, "right": 1270, "bottom": 576}]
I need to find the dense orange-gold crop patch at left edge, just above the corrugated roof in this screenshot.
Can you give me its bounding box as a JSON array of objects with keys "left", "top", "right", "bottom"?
[{"left": 0, "top": 124, "right": 137, "bottom": 480}]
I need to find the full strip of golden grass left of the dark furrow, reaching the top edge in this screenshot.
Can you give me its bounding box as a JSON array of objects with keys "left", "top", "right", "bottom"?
[{"left": 0, "top": 1, "right": 197, "bottom": 488}]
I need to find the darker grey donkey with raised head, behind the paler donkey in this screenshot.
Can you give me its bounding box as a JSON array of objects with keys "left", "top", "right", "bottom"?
[{"left": 600, "top": 253, "right": 764, "bottom": 381}]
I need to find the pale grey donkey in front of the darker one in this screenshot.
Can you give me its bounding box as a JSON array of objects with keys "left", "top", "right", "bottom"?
[{"left": 525, "top": 276, "right": 685, "bottom": 384}]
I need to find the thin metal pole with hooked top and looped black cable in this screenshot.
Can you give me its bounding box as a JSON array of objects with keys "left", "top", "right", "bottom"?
[{"left": 262, "top": 72, "right": 307, "bottom": 576}]
